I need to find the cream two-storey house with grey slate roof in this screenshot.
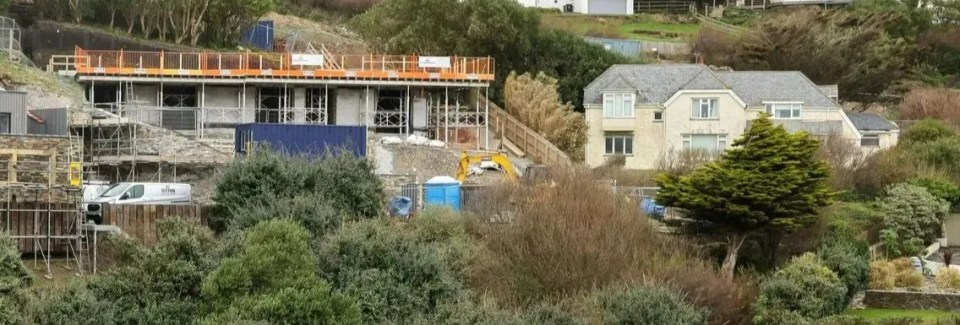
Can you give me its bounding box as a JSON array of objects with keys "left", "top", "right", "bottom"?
[{"left": 584, "top": 64, "right": 899, "bottom": 169}]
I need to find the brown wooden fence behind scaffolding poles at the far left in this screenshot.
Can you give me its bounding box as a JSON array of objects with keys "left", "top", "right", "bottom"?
[{"left": 0, "top": 202, "right": 80, "bottom": 253}]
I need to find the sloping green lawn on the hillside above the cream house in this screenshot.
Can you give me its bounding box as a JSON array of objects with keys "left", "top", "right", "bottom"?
[{"left": 541, "top": 14, "right": 700, "bottom": 42}]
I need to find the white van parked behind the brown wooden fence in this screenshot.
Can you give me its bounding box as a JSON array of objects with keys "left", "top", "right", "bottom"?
[{"left": 83, "top": 183, "right": 193, "bottom": 224}]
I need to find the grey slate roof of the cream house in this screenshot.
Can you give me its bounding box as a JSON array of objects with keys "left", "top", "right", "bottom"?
[{"left": 583, "top": 64, "right": 837, "bottom": 107}]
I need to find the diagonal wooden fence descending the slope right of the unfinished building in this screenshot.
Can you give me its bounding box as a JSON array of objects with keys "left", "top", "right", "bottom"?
[{"left": 481, "top": 97, "right": 573, "bottom": 166}]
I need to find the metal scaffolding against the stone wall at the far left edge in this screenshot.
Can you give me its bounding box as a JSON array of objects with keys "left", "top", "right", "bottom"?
[{"left": 0, "top": 140, "right": 89, "bottom": 278}]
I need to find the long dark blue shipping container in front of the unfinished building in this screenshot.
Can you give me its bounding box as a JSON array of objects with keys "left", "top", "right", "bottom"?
[{"left": 234, "top": 123, "right": 367, "bottom": 157}]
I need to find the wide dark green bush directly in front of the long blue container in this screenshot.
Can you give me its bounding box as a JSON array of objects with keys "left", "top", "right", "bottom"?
[{"left": 211, "top": 148, "right": 383, "bottom": 234}]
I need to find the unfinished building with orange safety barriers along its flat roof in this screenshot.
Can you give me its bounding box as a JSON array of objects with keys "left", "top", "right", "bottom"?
[{"left": 58, "top": 48, "right": 494, "bottom": 180}]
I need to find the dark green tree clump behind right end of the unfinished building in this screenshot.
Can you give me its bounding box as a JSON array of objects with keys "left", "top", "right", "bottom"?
[{"left": 353, "top": 0, "right": 627, "bottom": 109}]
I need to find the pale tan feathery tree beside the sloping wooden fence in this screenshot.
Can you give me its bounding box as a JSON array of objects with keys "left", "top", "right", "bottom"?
[{"left": 503, "top": 72, "right": 587, "bottom": 160}]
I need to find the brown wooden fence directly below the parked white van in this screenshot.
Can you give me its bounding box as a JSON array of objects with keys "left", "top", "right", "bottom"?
[{"left": 103, "top": 205, "right": 207, "bottom": 247}]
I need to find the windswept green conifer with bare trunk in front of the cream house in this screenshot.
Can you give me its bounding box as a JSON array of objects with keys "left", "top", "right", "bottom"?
[{"left": 657, "top": 114, "right": 833, "bottom": 278}]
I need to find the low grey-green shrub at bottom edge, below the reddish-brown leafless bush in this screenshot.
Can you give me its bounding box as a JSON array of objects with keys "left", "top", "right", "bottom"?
[{"left": 591, "top": 285, "right": 708, "bottom": 325}]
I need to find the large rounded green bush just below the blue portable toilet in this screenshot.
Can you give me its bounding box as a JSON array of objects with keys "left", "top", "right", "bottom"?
[{"left": 319, "top": 209, "right": 474, "bottom": 324}]
